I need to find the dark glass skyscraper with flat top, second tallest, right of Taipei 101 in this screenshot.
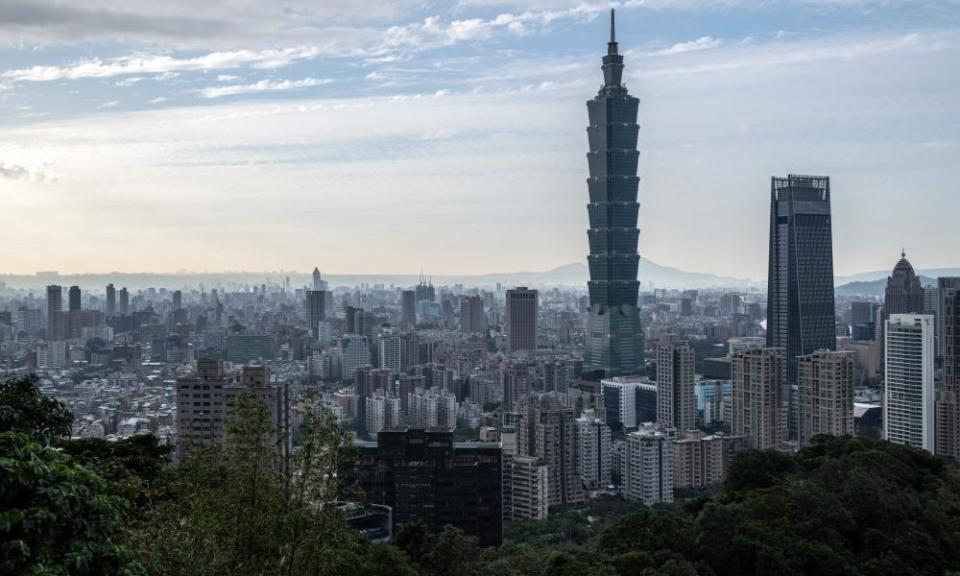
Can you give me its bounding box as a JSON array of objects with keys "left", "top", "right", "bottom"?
[{"left": 767, "top": 174, "right": 837, "bottom": 385}]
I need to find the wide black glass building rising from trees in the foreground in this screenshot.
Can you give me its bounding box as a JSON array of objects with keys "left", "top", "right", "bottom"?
[{"left": 348, "top": 428, "right": 503, "bottom": 546}]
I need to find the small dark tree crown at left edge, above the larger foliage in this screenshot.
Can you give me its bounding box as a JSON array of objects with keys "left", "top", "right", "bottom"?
[{"left": 0, "top": 374, "right": 73, "bottom": 443}]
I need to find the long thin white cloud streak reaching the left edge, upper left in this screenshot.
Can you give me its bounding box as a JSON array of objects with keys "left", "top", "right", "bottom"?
[{"left": 0, "top": 46, "right": 320, "bottom": 82}]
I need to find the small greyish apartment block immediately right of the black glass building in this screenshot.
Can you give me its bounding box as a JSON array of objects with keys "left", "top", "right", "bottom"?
[{"left": 503, "top": 454, "right": 550, "bottom": 521}]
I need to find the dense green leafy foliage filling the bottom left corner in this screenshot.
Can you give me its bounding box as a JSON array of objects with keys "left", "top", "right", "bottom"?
[{"left": 0, "top": 432, "right": 138, "bottom": 575}]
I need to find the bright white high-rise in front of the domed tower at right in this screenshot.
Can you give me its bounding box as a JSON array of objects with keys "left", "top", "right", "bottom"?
[{"left": 883, "top": 314, "right": 936, "bottom": 452}]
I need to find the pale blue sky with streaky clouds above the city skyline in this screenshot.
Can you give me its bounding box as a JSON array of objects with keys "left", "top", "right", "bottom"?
[{"left": 0, "top": 0, "right": 960, "bottom": 279}]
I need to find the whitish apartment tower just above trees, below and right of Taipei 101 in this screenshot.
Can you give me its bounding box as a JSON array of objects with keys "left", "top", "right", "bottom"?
[{"left": 620, "top": 423, "right": 673, "bottom": 506}]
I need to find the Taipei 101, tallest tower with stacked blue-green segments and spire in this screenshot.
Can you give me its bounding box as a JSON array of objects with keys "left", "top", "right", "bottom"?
[{"left": 584, "top": 10, "right": 644, "bottom": 377}]
